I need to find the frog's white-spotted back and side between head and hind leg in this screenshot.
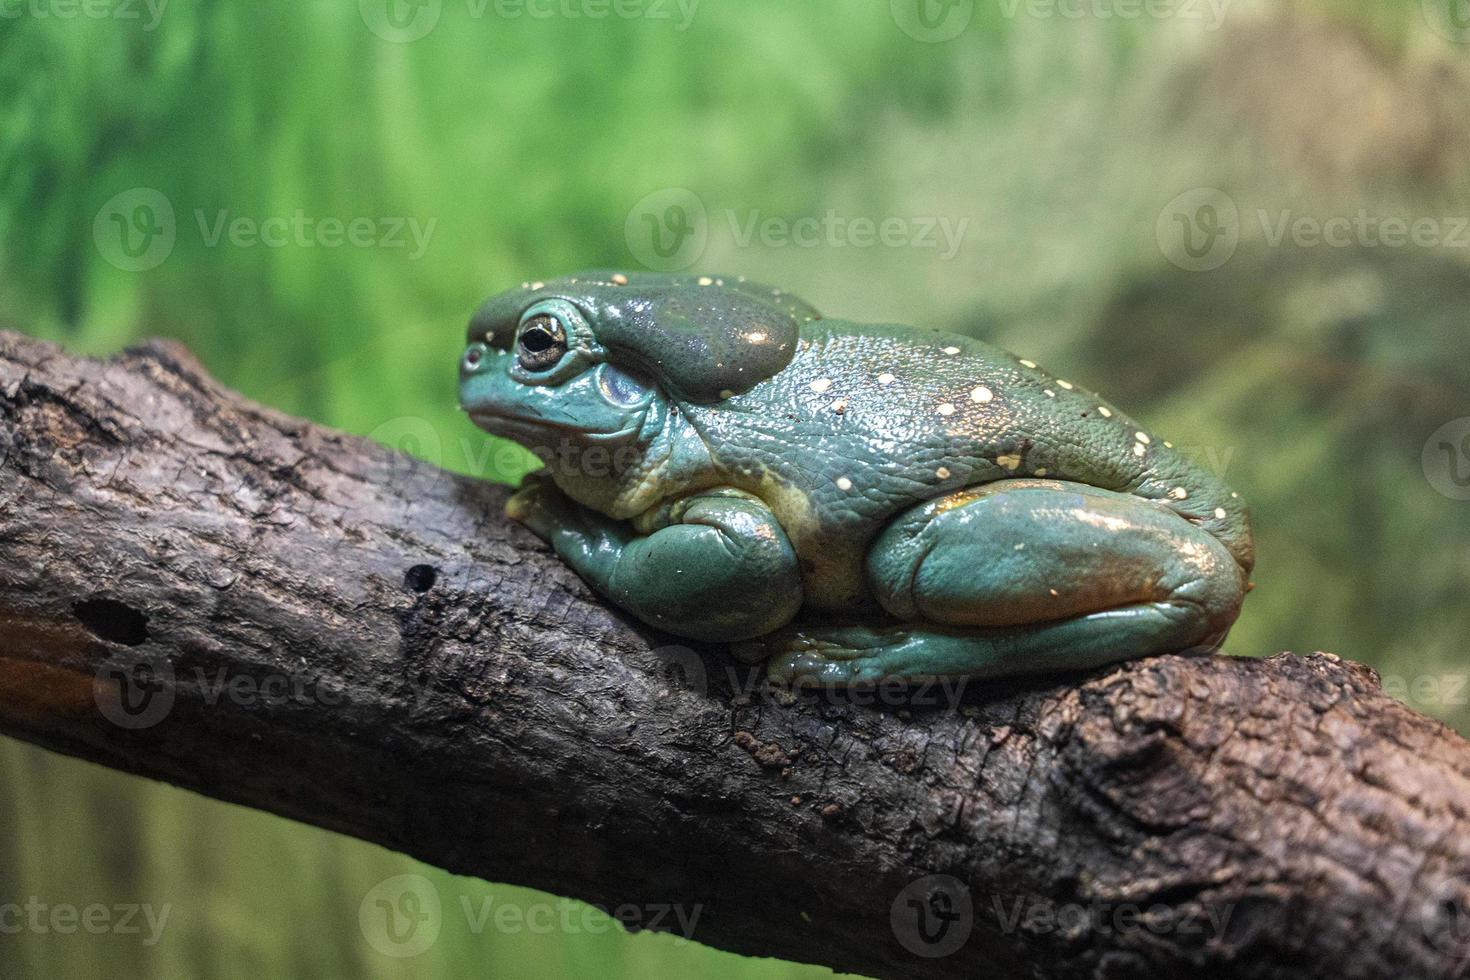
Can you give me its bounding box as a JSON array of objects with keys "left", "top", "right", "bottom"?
[{"left": 687, "top": 320, "right": 1252, "bottom": 605}]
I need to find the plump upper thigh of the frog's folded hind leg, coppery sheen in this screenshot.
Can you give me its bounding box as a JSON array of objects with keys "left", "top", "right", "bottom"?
[{"left": 867, "top": 480, "right": 1245, "bottom": 630}]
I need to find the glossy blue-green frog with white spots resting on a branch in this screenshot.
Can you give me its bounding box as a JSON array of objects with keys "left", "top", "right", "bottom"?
[{"left": 459, "top": 269, "right": 1254, "bottom": 688}]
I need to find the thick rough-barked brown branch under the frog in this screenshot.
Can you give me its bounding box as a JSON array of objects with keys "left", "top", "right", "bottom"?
[{"left": 0, "top": 335, "right": 1470, "bottom": 980}]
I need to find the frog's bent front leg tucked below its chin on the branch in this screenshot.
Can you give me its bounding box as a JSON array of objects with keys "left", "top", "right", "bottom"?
[{"left": 506, "top": 480, "right": 801, "bottom": 641}]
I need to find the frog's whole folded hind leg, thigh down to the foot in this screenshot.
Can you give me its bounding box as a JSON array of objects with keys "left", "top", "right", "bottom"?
[{"left": 757, "top": 480, "right": 1245, "bottom": 685}]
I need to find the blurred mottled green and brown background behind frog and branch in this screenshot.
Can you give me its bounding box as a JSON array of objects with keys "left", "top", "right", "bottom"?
[{"left": 0, "top": 0, "right": 1470, "bottom": 979}]
